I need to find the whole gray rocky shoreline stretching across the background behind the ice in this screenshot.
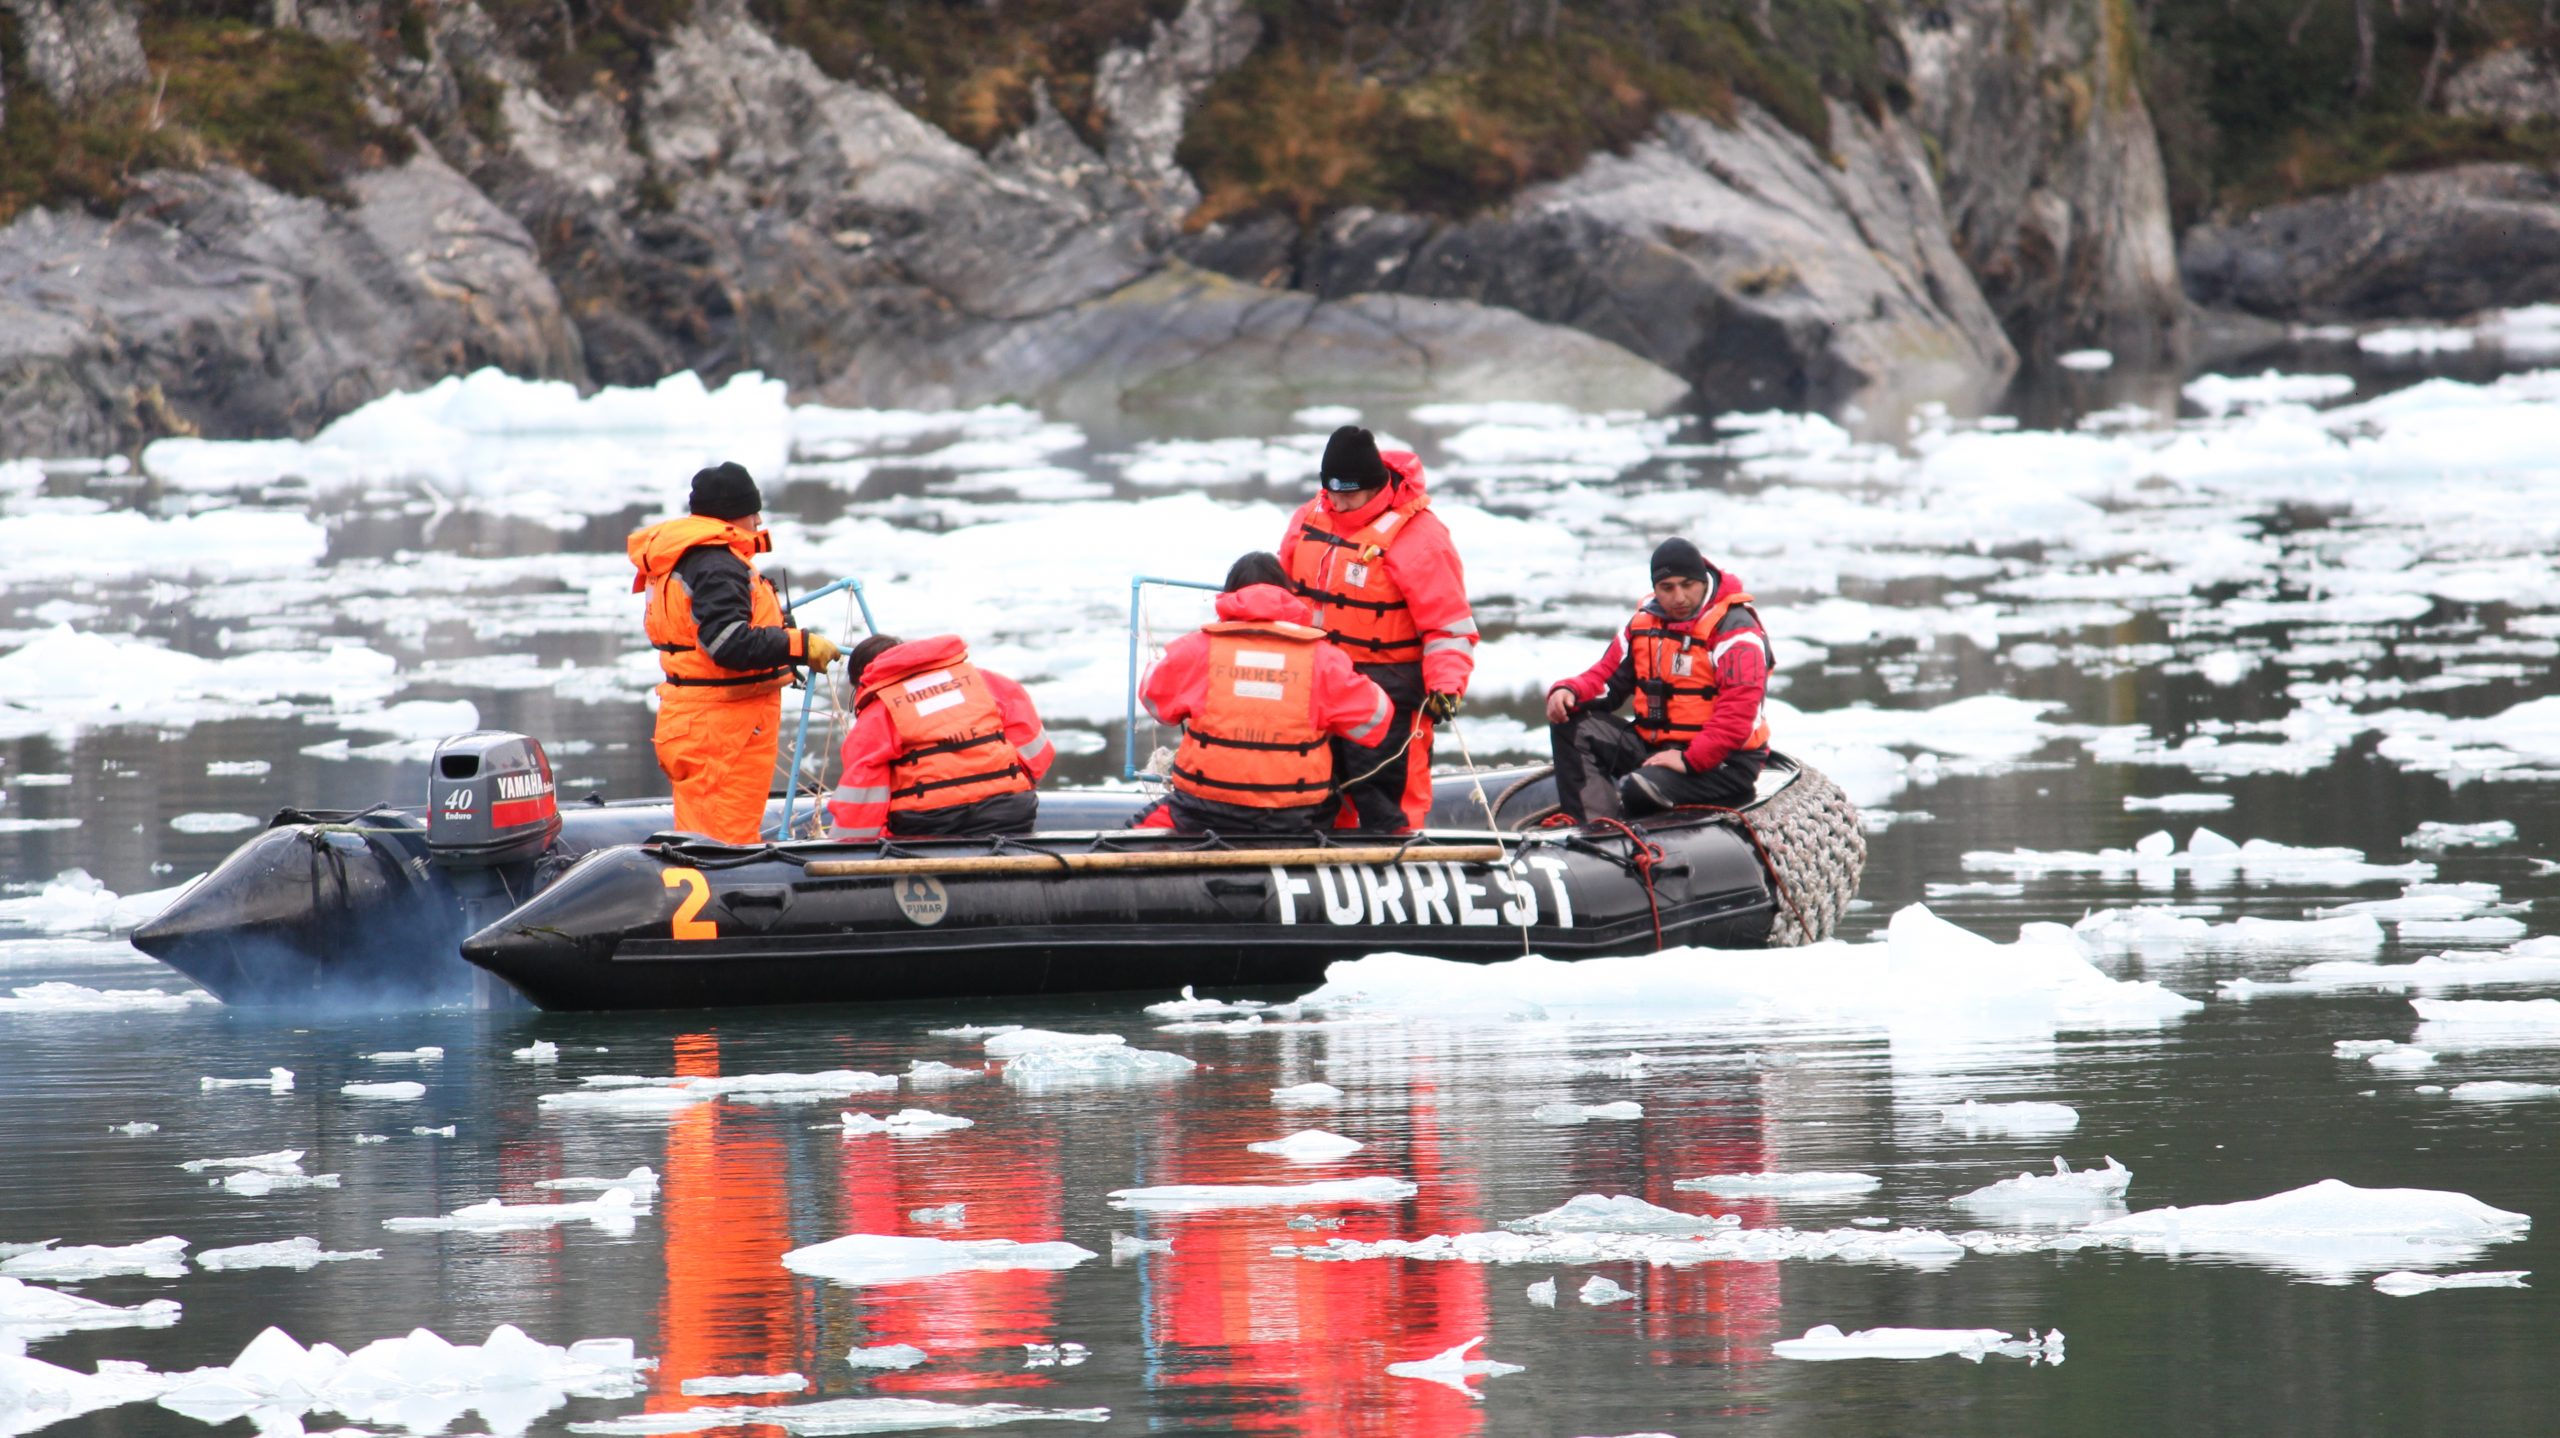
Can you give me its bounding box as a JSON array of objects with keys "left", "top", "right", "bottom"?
[{"left": 0, "top": 0, "right": 2560, "bottom": 455}]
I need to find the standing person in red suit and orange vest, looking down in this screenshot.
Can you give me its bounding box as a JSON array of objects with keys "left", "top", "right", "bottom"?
[{"left": 1280, "top": 425, "right": 1477, "bottom": 829}]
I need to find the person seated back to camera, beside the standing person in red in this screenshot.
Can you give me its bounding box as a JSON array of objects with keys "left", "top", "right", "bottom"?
[{"left": 1139, "top": 553, "right": 1395, "bottom": 834}]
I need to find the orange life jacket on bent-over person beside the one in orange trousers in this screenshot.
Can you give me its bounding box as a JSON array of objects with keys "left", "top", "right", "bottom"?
[{"left": 852, "top": 635, "right": 1032, "bottom": 814}]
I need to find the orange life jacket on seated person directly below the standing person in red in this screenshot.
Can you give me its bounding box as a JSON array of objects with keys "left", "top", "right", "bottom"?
[{"left": 1172, "top": 619, "right": 1334, "bottom": 809}]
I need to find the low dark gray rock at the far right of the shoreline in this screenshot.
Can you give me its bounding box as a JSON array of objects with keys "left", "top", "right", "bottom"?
[{"left": 2181, "top": 164, "right": 2560, "bottom": 320}]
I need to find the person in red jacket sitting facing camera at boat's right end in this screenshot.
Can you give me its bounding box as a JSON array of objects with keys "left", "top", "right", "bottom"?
[{"left": 1546, "top": 537, "right": 1769, "bottom": 824}]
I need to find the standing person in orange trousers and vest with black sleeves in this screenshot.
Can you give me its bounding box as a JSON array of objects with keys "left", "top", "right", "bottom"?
[{"left": 627, "top": 463, "right": 837, "bottom": 844}]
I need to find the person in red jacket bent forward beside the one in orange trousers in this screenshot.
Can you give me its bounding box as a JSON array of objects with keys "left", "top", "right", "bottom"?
[{"left": 827, "top": 635, "right": 1057, "bottom": 839}]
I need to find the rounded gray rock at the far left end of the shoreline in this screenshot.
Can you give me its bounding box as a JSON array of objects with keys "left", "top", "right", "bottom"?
[{"left": 0, "top": 154, "right": 581, "bottom": 455}]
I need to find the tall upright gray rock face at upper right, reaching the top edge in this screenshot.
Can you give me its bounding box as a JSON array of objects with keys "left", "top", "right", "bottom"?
[{"left": 1900, "top": 0, "right": 2186, "bottom": 363}]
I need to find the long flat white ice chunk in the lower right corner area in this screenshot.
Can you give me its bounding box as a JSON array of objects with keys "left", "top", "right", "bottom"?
[{"left": 2081, "top": 1180, "right": 2532, "bottom": 1277}]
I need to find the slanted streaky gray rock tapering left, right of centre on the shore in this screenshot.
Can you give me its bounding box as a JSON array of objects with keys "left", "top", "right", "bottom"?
[{"left": 1280, "top": 102, "right": 2017, "bottom": 407}]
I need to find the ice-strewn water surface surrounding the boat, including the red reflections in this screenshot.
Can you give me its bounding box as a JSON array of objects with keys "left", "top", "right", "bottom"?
[{"left": 0, "top": 330, "right": 2560, "bottom": 1435}]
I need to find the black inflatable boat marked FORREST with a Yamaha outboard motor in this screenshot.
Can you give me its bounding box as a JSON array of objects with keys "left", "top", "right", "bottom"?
[{"left": 133, "top": 734, "right": 1866, "bottom": 1008}]
